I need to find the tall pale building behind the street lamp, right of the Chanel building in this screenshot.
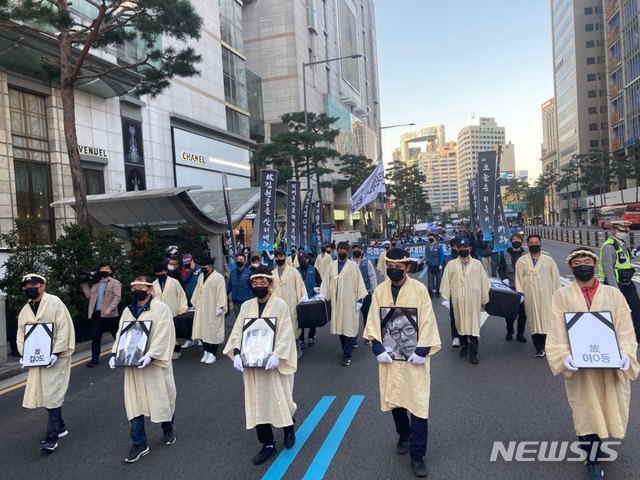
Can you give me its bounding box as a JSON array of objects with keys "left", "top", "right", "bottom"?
[{"left": 243, "top": 0, "right": 380, "bottom": 222}]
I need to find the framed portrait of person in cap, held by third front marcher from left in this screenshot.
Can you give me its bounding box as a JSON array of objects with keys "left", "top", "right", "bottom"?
[{"left": 240, "top": 318, "right": 276, "bottom": 368}]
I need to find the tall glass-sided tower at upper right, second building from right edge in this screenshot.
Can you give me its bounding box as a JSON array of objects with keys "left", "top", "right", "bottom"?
[{"left": 551, "top": 0, "right": 609, "bottom": 222}]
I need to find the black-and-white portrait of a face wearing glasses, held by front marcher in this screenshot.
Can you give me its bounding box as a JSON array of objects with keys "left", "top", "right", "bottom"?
[{"left": 380, "top": 307, "right": 418, "bottom": 360}]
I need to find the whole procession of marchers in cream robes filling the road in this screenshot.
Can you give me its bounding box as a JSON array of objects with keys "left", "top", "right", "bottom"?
[{"left": 11, "top": 218, "right": 640, "bottom": 479}]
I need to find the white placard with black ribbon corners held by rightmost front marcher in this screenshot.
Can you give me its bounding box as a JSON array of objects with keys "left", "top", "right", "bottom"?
[{"left": 564, "top": 312, "right": 621, "bottom": 368}]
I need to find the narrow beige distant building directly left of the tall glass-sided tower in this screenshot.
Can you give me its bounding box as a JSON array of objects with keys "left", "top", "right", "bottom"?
[{"left": 540, "top": 98, "right": 558, "bottom": 225}]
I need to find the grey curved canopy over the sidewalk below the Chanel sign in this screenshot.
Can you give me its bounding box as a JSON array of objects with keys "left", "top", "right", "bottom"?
[{"left": 51, "top": 186, "right": 283, "bottom": 234}]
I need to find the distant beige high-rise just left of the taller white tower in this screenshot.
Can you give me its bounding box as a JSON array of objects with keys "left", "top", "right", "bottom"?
[{"left": 419, "top": 142, "right": 458, "bottom": 213}]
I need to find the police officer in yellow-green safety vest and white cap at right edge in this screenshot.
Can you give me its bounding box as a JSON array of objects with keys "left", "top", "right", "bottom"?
[{"left": 598, "top": 220, "right": 640, "bottom": 340}]
